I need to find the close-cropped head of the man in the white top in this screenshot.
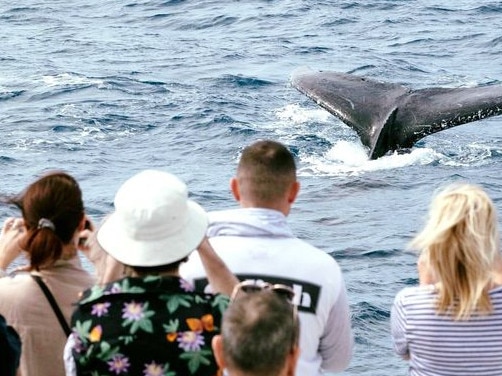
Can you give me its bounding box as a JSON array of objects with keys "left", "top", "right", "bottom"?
[{"left": 230, "top": 140, "right": 299, "bottom": 215}]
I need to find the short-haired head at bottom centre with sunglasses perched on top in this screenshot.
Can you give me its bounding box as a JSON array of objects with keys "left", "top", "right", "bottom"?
[{"left": 213, "top": 290, "right": 299, "bottom": 376}]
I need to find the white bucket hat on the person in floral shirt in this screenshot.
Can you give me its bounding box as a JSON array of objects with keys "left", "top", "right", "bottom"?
[{"left": 97, "top": 170, "right": 208, "bottom": 266}]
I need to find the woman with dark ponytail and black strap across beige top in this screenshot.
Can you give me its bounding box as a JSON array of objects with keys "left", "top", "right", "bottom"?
[{"left": 0, "top": 171, "right": 95, "bottom": 376}]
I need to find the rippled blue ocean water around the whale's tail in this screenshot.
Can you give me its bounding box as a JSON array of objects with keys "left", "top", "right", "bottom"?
[{"left": 0, "top": 0, "right": 502, "bottom": 376}]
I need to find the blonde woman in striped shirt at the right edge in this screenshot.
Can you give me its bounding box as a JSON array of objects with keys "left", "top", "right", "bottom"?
[{"left": 391, "top": 184, "right": 502, "bottom": 376}]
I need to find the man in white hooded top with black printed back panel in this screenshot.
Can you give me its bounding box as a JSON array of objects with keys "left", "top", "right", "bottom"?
[{"left": 180, "top": 140, "right": 354, "bottom": 376}]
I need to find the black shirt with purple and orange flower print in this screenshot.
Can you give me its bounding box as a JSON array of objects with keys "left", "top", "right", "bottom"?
[{"left": 72, "top": 276, "right": 228, "bottom": 376}]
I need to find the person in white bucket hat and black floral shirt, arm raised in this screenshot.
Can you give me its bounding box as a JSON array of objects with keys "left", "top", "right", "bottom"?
[{"left": 66, "top": 170, "right": 238, "bottom": 376}]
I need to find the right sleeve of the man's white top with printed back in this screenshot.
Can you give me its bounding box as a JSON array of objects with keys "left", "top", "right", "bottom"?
[{"left": 319, "top": 280, "right": 354, "bottom": 372}]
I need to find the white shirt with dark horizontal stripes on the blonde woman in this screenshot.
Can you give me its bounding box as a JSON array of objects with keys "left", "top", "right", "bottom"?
[{"left": 391, "top": 285, "right": 502, "bottom": 376}]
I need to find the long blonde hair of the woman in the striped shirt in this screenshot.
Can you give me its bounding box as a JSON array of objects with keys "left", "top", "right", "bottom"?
[{"left": 410, "top": 184, "right": 499, "bottom": 320}]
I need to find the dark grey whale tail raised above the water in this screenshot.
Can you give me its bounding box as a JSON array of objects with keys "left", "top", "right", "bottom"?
[{"left": 291, "top": 71, "right": 502, "bottom": 159}]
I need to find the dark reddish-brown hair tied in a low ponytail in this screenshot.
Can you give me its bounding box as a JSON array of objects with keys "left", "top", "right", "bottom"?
[{"left": 9, "top": 171, "right": 84, "bottom": 270}]
